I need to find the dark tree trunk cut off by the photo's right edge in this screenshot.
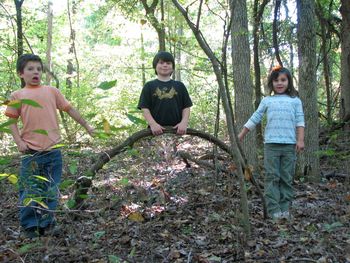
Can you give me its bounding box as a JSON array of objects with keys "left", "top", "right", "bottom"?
[{"left": 340, "top": 0, "right": 350, "bottom": 126}]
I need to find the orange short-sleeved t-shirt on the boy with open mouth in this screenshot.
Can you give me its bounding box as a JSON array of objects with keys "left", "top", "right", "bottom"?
[{"left": 5, "top": 85, "right": 71, "bottom": 151}]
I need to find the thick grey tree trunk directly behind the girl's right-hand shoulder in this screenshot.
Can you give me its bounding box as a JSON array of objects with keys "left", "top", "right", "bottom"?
[{"left": 297, "top": 0, "right": 320, "bottom": 181}]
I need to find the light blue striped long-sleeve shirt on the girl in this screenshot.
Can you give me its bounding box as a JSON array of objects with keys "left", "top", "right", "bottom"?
[{"left": 244, "top": 94, "right": 305, "bottom": 144}]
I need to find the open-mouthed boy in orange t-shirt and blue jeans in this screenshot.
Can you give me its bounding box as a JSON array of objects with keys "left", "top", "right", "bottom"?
[{"left": 5, "top": 54, "right": 94, "bottom": 238}]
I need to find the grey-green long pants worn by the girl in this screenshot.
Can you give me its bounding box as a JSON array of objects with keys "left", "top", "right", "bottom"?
[{"left": 264, "top": 143, "right": 296, "bottom": 216}]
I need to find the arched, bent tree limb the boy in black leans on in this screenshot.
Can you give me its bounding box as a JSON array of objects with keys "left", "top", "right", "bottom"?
[{"left": 73, "top": 127, "right": 266, "bottom": 221}]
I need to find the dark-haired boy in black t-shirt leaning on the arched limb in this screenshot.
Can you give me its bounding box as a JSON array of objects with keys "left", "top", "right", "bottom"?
[{"left": 138, "top": 51, "right": 192, "bottom": 135}]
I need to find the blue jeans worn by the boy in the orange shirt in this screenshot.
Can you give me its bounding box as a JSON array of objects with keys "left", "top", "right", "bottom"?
[{"left": 19, "top": 150, "right": 62, "bottom": 229}]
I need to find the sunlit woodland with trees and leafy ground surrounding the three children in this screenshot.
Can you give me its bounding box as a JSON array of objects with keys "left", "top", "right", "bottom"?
[{"left": 0, "top": 0, "right": 350, "bottom": 262}]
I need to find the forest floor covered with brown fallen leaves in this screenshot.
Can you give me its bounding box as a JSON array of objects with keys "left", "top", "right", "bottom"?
[{"left": 0, "top": 135, "right": 350, "bottom": 263}]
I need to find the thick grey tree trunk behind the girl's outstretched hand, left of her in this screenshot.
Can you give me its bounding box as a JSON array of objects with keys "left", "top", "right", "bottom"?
[{"left": 231, "top": 0, "right": 258, "bottom": 167}]
